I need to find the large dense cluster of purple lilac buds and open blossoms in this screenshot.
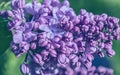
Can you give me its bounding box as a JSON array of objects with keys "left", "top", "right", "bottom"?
[{"left": 0, "top": 0, "right": 120, "bottom": 75}]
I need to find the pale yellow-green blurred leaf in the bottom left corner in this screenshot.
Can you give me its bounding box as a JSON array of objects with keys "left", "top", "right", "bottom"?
[{"left": 0, "top": 49, "right": 25, "bottom": 75}]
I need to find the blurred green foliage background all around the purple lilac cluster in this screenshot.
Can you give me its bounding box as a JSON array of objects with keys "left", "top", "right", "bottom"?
[{"left": 0, "top": 0, "right": 120, "bottom": 75}]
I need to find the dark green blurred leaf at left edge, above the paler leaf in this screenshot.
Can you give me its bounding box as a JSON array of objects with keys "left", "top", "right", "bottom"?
[{"left": 0, "top": 18, "right": 12, "bottom": 55}]
